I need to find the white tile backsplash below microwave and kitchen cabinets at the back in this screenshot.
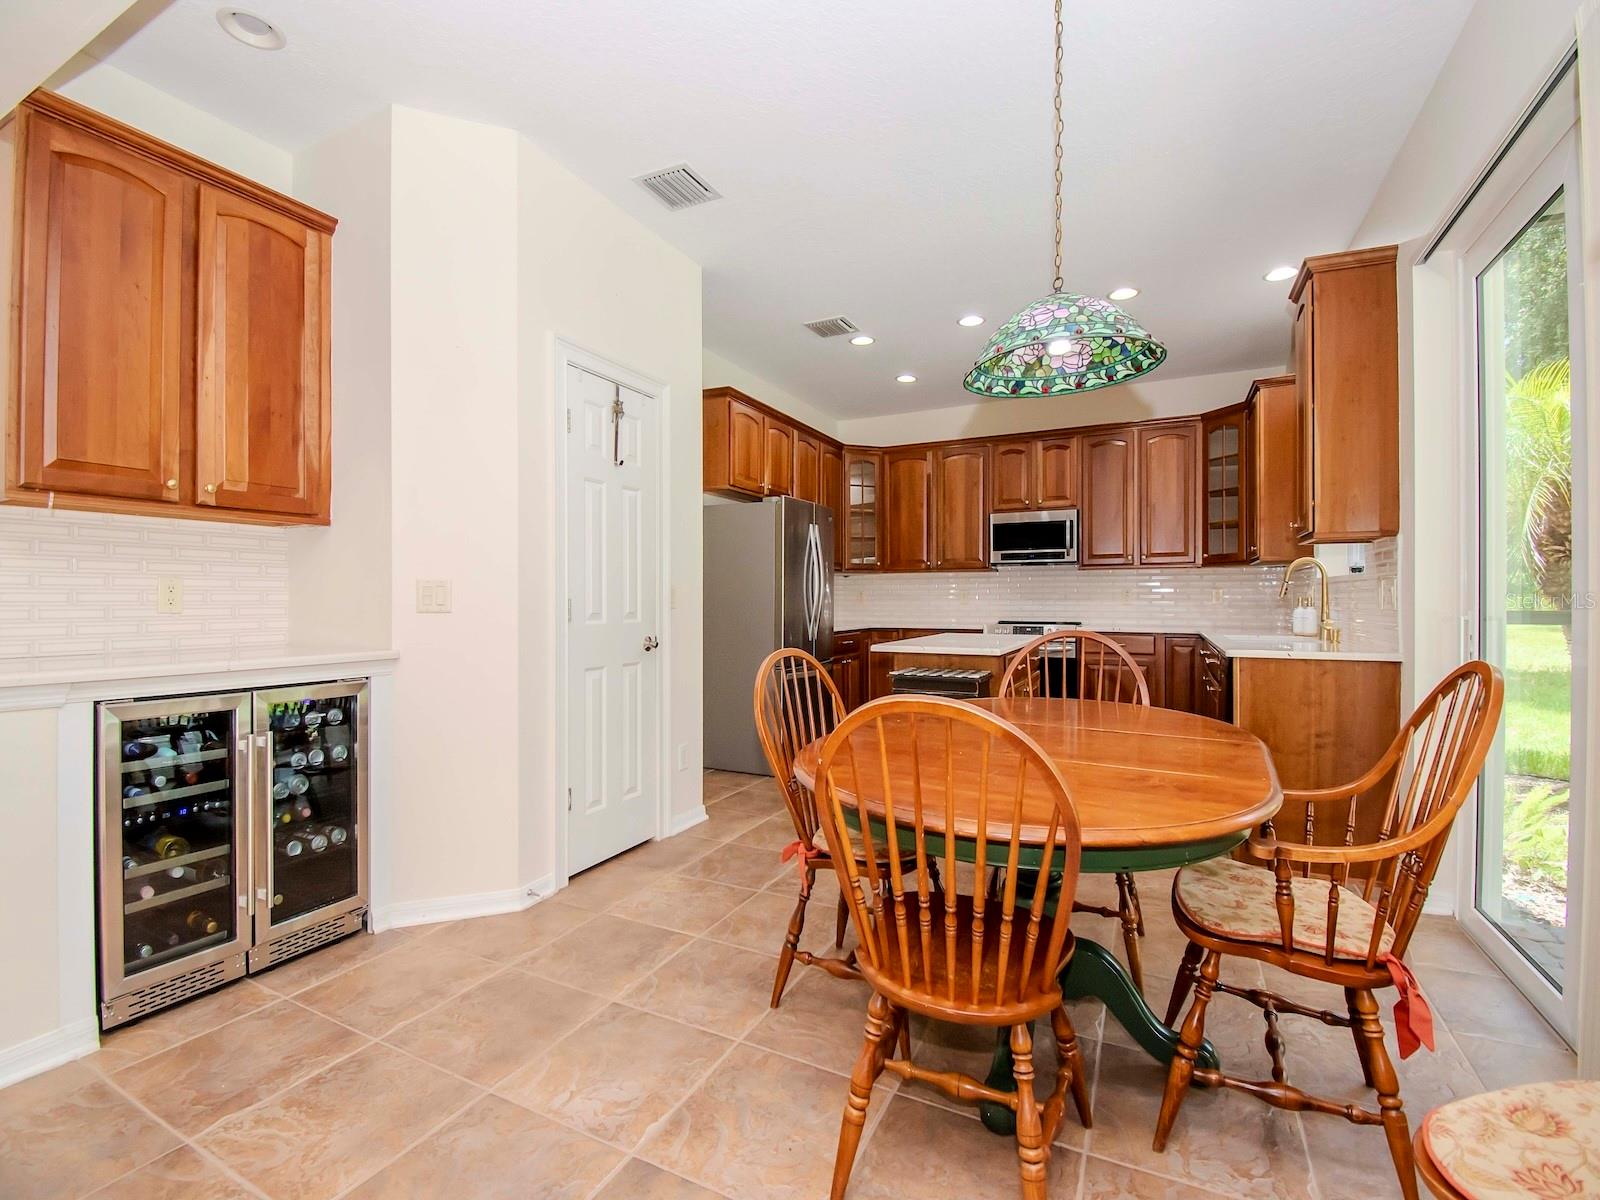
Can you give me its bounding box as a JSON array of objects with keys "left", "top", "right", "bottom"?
[{"left": 834, "top": 538, "right": 1400, "bottom": 651}]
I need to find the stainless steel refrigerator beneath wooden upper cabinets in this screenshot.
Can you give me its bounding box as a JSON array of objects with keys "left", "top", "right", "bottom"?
[{"left": 706, "top": 496, "right": 834, "bottom": 774}]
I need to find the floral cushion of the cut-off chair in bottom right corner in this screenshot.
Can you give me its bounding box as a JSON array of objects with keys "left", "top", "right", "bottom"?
[{"left": 1421, "top": 1080, "right": 1600, "bottom": 1200}]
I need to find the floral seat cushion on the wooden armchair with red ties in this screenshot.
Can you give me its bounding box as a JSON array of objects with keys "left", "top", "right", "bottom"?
[{"left": 1173, "top": 858, "right": 1395, "bottom": 958}]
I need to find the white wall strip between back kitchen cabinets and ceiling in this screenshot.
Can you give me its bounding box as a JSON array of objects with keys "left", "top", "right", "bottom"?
[{"left": 837, "top": 364, "right": 1290, "bottom": 446}]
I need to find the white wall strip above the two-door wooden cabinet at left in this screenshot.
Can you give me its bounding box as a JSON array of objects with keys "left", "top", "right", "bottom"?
[{"left": 45, "top": 54, "right": 298, "bottom": 195}]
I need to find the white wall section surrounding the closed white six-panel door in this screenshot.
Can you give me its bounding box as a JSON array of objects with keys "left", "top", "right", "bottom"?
[{"left": 517, "top": 141, "right": 704, "bottom": 880}]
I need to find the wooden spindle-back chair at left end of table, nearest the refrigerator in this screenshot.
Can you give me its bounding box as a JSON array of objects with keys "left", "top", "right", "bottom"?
[{"left": 755, "top": 648, "right": 861, "bottom": 1008}]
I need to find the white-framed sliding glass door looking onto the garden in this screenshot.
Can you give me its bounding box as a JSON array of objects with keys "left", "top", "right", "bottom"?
[{"left": 1462, "top": 129, "right": 1590, "bottom": 1035}]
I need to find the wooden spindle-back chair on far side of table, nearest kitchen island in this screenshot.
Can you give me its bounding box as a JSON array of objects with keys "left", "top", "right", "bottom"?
[{"left": 1000, "top": 629, "right": 1150, "bottom": 992}]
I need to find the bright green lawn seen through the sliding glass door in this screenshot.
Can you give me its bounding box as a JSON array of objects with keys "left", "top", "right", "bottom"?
[{"left": 1506, "top": 626, "right": 1573, "bottom": 779}]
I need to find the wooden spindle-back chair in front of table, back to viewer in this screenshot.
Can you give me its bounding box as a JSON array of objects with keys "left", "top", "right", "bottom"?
[{"left": 816, "top": 696, "right": 1090, "bottom": 1200}]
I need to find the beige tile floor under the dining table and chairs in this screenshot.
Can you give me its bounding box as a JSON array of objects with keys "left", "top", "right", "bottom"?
[{"left": 0, "top": 771, "right": 1574, "bottom": 1200}]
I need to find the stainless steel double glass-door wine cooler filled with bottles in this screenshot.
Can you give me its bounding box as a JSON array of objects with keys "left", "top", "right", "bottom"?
[{"left": 98, "top": 680, "right": 370, "bottom": 1029}]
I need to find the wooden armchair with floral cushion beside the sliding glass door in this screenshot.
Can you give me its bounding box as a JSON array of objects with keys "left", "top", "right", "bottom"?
[{"left": 1155, "top": 662, "right": 1504, "bottom": 1200}]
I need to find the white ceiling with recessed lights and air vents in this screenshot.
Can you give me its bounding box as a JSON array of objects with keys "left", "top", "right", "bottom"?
[{"left": 84, "top": 0, "right": 1470, "bottom": 416}]
